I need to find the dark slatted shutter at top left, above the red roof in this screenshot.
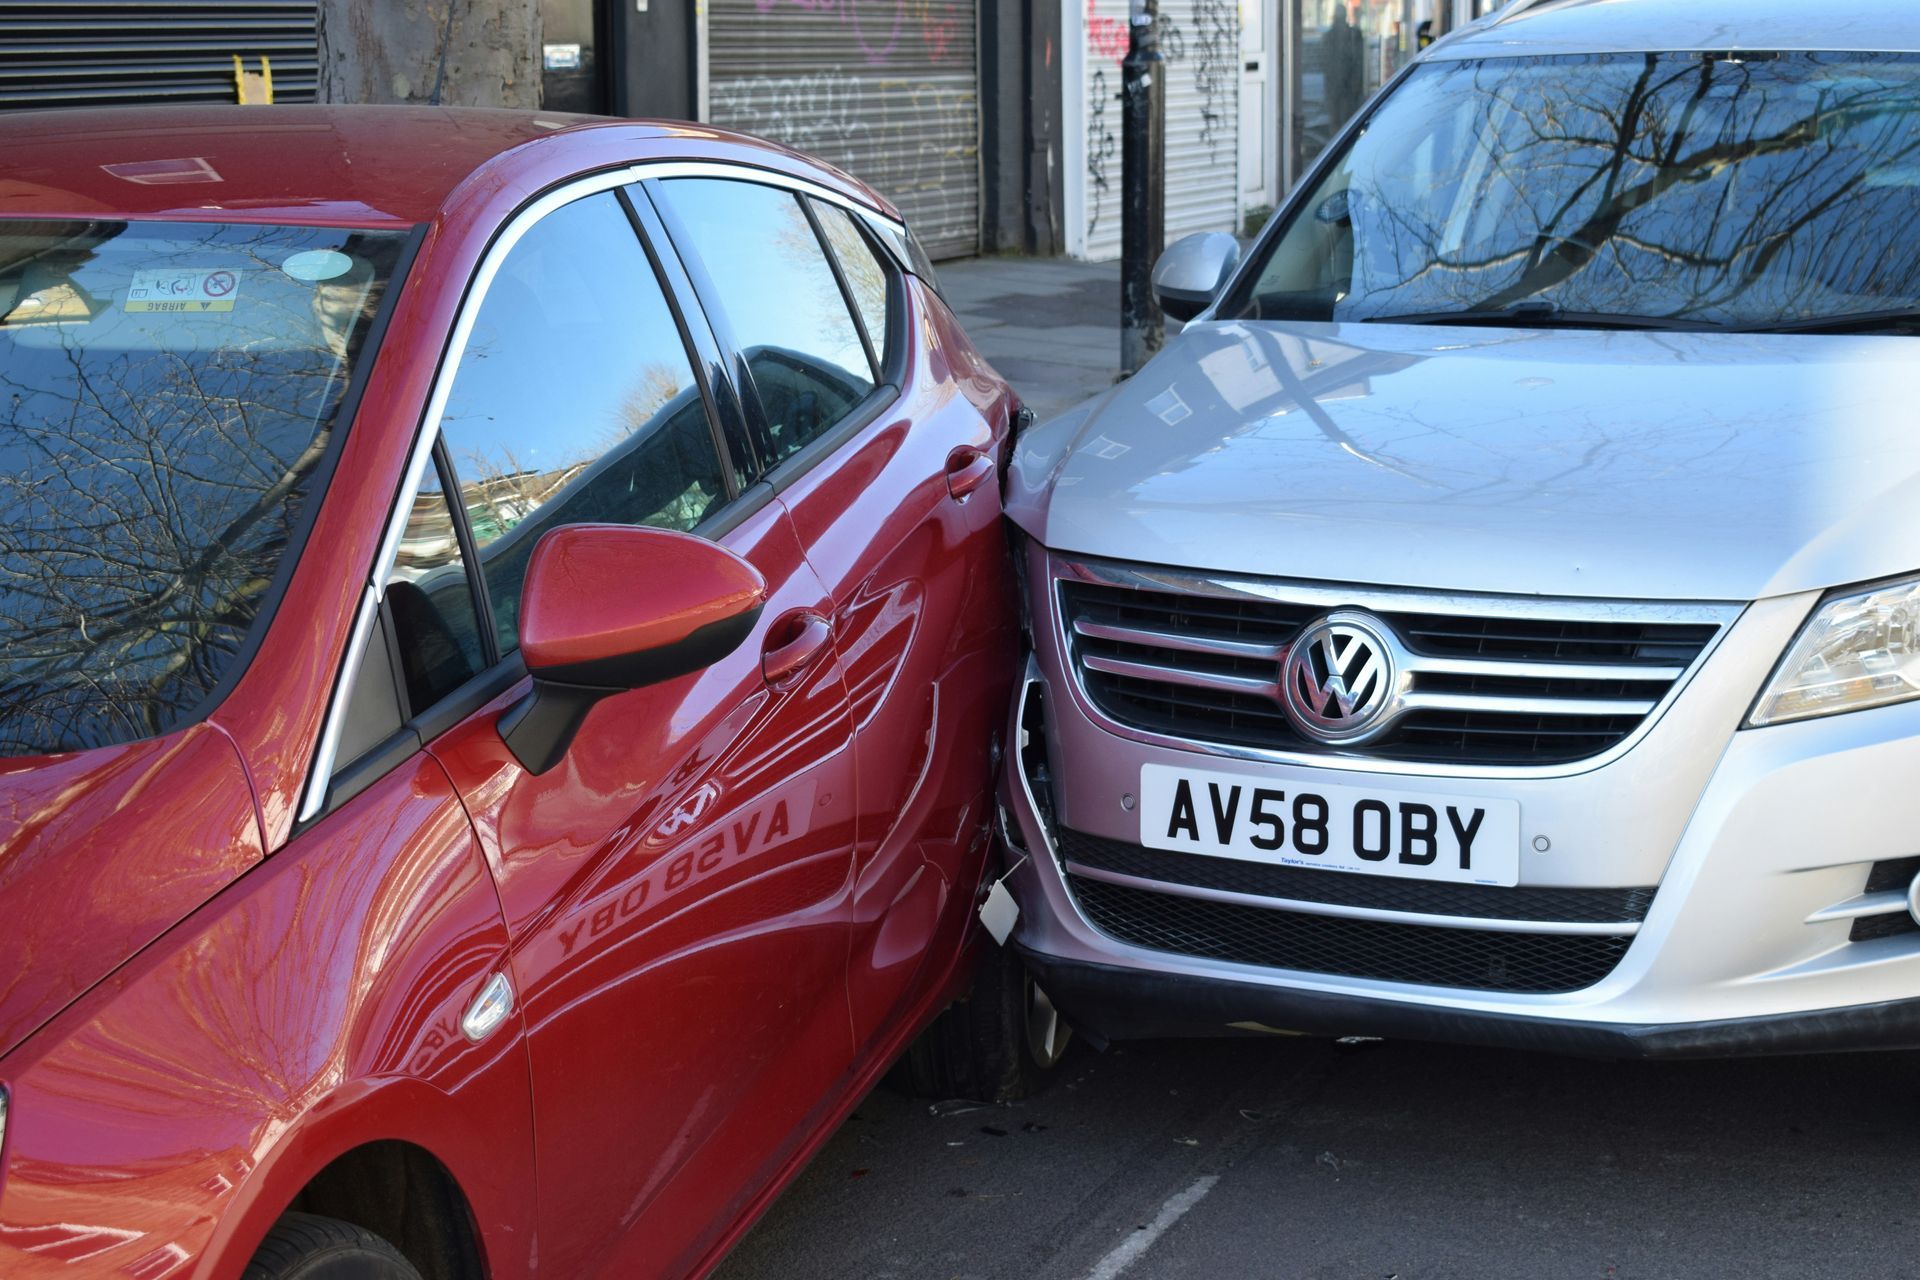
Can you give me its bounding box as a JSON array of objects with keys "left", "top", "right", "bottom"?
[{"left": 0, "top": 0, "right": 319, "bottom": 107}]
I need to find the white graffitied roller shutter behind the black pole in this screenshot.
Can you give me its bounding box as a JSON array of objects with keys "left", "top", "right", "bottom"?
[{"left": 1081, "top": 0, "right": 1240, "bottom": 259}]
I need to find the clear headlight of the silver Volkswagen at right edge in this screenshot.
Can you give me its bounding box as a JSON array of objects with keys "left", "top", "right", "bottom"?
[{"left": 1747, "top": 578, "right": 1920, "bottom": 725}]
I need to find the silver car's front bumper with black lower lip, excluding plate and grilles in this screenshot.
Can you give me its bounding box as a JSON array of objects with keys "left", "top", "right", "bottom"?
[{"left": 1002, "top": 568, "right": 1920, "bottom": 1057}]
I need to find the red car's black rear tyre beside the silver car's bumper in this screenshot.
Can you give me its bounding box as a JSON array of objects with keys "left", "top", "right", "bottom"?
[{"left": 897, "top": 942, "right": 1073, "bottom": 1102}]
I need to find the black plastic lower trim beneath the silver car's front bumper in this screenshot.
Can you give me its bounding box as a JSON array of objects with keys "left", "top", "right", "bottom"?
[{"left": 1020, "top": 946, "right": 1920, "bottom": 1059}]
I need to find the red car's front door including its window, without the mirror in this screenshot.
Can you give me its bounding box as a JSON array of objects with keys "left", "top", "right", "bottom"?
[{"left": 401, "top": 190, "right": 854, "bottom": 1278}]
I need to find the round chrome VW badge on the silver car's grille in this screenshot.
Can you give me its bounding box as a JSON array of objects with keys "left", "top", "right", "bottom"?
[{"left": 1281, "top": 610, "right": 1400, "bottom": 743}]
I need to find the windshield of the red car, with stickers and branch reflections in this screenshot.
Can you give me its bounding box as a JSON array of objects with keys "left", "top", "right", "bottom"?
[{"left": 0, "top": 221, "right": 405, "bottom": 756}]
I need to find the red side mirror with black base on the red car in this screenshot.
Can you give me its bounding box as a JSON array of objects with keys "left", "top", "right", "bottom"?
[{"left": 499, "top": 524, "right": 766, "bottom": 773}]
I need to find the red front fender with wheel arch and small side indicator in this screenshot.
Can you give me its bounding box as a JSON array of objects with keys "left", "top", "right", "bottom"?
[{"left": 0, "top": 756, "right": 534, "bottom": 1280}]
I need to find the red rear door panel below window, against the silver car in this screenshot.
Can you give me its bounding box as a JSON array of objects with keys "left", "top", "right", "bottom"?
[{"left": 781, "top": 284, "right": 1016, "bottom": 1042}]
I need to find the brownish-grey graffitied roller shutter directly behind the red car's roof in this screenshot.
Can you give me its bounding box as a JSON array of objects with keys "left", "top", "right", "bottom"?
[{"left": 707, "top": 0, "right": 979, "bottom": 257}]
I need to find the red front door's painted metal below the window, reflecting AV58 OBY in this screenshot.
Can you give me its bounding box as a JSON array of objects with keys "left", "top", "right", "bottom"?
[{"left": 432, "top": 503, "right": 854, "bottom": 1280}]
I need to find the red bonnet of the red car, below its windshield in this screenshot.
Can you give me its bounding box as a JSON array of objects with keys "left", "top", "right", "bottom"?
[{"left": 0, "top": 725, "right": 261, "bottom": 1066}]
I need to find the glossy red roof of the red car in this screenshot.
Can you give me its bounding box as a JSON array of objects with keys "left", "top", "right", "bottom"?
[{"left": 0, "top": 106, "right": 887, "bottom": 226}]
